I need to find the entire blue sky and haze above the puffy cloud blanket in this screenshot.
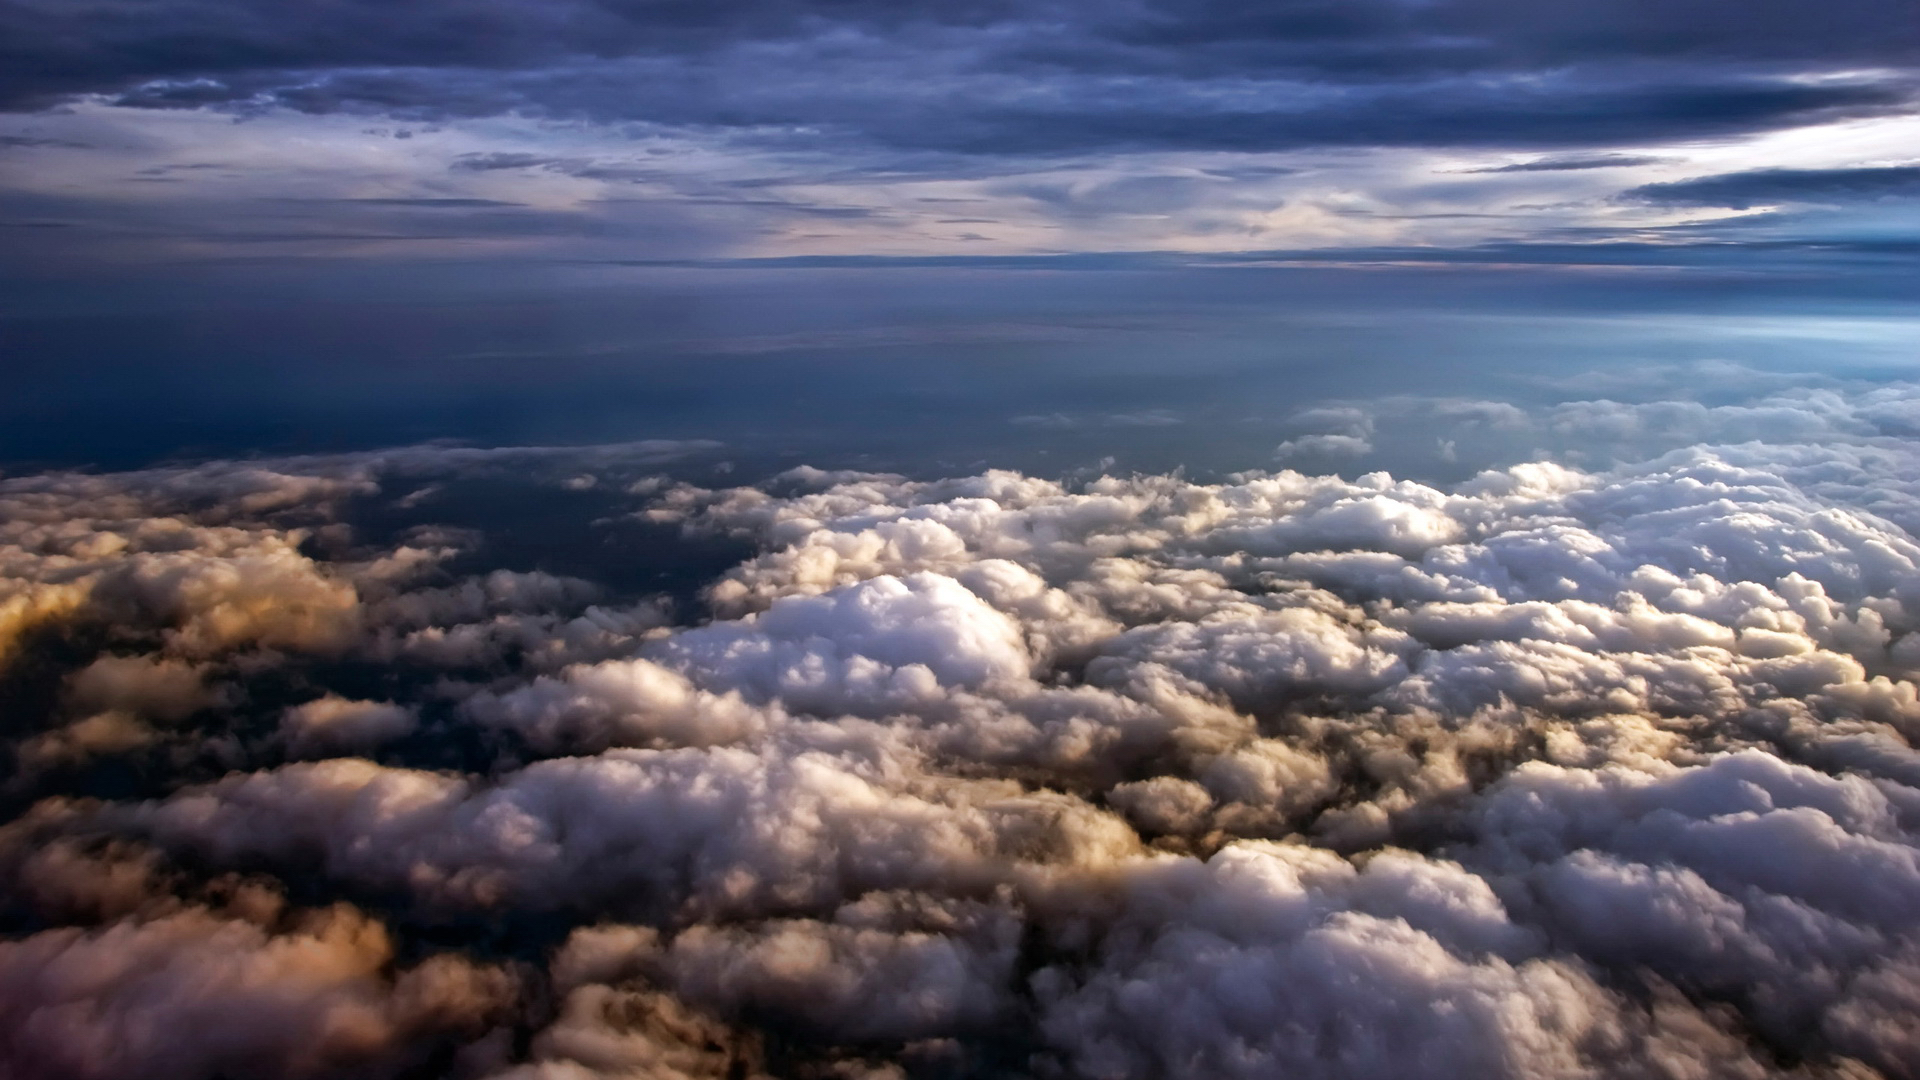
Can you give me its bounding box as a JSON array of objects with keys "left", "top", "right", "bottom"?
[{"left": 0, "top": 0, "right": 1920, "bottom": 465}]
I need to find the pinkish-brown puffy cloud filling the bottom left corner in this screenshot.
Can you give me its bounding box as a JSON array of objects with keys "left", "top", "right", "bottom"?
[{"left": 0, "top": 907, "right": 513, "bottom": 1080}]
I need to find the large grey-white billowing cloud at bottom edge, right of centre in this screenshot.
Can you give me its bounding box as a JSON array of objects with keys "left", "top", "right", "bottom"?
[{"left": 1035, "top": 844, "right": 1759, "bottom": 1078}]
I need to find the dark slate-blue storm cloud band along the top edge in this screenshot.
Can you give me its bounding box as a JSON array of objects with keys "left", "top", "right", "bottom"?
[{"left": 0, "top": 0, "right": 1920, "bottom": 155}]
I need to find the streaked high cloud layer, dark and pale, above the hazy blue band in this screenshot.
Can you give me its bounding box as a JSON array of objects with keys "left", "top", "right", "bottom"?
[{"left": 0, "top": 0, "right": 1920, "bottom": 276}]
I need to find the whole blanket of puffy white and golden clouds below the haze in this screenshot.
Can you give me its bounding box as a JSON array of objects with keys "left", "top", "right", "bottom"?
[{"left": 0, "top": 386, "right": 1920, "bottom": 1080}]
